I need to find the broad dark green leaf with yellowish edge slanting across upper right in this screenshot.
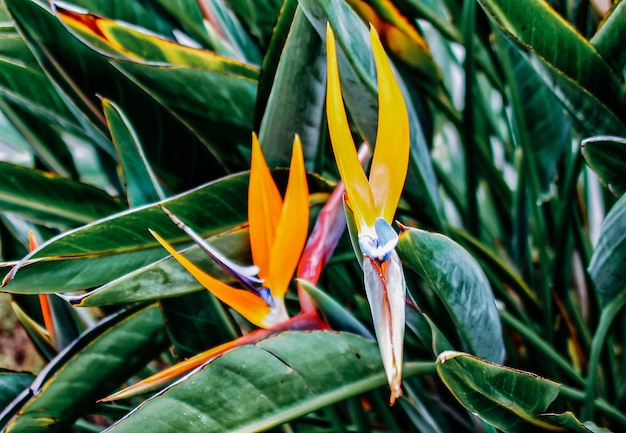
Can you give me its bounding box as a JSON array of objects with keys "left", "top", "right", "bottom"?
[{"left": 479, "top": 0, "right": 626, "bottom": 135}]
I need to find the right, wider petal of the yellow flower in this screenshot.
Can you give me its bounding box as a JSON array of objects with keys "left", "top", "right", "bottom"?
[{"left": 369, "top": 27, "right": 410, "bottom": 223}]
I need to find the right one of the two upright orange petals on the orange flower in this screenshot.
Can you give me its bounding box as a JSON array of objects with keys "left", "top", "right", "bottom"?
[{"left": 265, "top": 135, "right": 309, "bottom": 298}]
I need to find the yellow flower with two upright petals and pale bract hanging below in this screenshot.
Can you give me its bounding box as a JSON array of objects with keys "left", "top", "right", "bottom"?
[{"left": 326, "top": 25, "right": 410, "bottom": 404}]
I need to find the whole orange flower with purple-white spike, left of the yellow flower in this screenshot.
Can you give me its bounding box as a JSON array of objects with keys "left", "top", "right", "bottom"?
[{"left": 152, "top": 135, "right": 309, "bottom": 328}]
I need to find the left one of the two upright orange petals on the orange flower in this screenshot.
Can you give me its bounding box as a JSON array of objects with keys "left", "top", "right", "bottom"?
[{"left": 248, "top": 134, "right": 283, "bottom": 279}]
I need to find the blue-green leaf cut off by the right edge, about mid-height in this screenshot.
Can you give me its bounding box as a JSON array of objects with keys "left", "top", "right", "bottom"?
[{"left": 588, "top": 195, "right": 626, "bottom": 304}]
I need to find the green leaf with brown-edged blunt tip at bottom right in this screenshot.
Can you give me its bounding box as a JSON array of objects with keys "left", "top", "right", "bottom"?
[{"left": 437, "top": 351, "right": 589, "bottom": 433}]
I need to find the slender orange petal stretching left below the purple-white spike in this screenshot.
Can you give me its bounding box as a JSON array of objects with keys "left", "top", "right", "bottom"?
[{"left": 150, "top": 230, "right": 271, "bottom": 328}]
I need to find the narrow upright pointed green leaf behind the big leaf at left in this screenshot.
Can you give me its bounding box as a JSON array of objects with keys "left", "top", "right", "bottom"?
[{"left": 102, "top": 99, "right": 165, "bottom": 207}]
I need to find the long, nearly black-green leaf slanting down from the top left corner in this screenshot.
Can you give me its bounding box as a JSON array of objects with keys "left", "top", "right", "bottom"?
[{"left": 7, "top": 0, "right": 227, "bottom": 192}]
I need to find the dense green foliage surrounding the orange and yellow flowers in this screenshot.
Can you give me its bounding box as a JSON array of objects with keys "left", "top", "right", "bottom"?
[{"left": 0, "top": 0, "right": 626, "bottom": 432}]
